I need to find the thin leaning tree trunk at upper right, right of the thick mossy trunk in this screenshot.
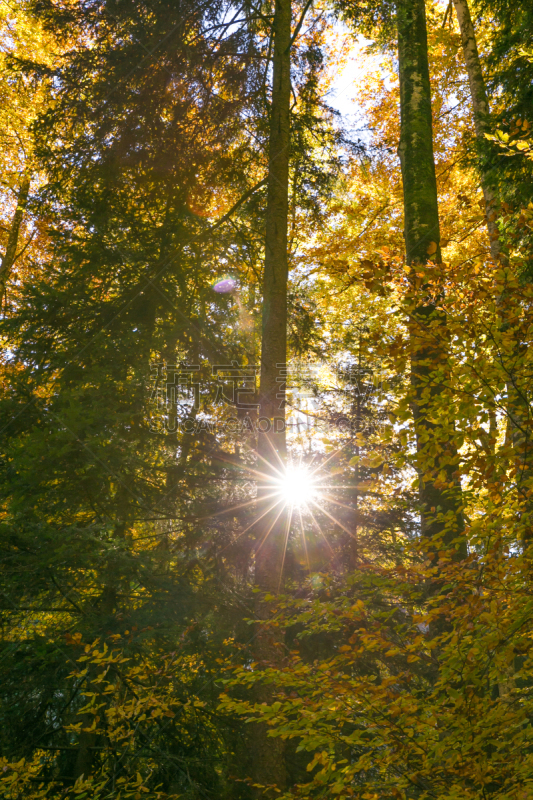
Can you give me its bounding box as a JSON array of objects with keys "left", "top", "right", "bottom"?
[{"left": 453, "top": 0, "right": 500, "bottom": 261}]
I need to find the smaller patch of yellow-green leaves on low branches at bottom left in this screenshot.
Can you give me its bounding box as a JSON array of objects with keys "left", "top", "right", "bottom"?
[{"left": 0, "top": 634, "right": 212, "bottom": 800}]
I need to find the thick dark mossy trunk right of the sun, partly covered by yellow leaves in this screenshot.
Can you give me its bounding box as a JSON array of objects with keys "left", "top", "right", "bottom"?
[{"left": 397, "top": 0, "right": 462, "bottom": 544}]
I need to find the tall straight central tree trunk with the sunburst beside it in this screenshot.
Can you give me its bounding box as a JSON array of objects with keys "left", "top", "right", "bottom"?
[{"left": 253, "top": 0, "right": 292, "bottom": 789}]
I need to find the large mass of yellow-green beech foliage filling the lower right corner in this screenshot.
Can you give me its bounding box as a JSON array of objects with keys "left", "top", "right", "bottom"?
[{"left": 223, "top": 536, "right": 533, "bottom": 800}]
